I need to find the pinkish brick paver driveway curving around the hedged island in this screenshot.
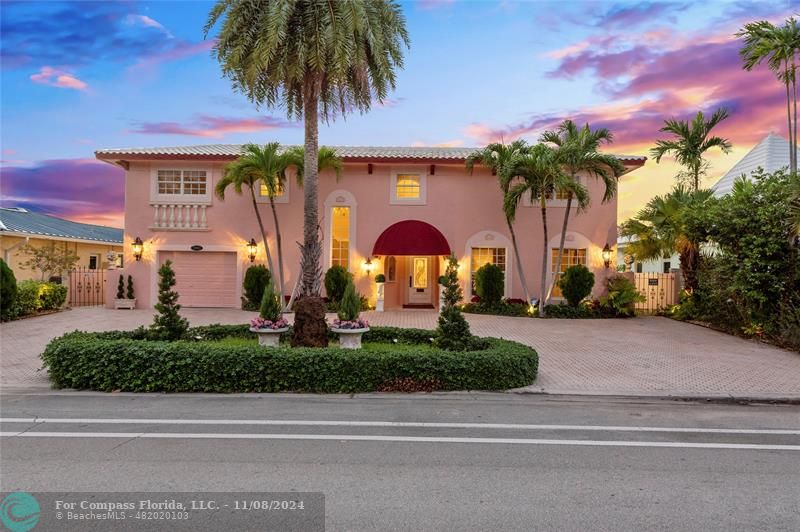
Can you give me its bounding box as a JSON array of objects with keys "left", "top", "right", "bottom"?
[{"left": 0, "top": 308, "right": 800, "bottom": 398}]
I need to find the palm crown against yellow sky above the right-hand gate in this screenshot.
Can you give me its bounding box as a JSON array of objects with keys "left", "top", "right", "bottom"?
[{"left": 650, "top": 108, "right": 732, "bottom": 190}]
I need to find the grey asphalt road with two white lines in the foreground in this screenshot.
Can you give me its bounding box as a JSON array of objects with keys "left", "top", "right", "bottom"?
[{"left": 0, "top": 393, "right": 800, "bottom": 531}]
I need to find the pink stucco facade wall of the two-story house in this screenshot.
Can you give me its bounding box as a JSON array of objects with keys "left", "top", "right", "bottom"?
[{"left": 107, "top": 161, "right": 624, "bottom": 308}]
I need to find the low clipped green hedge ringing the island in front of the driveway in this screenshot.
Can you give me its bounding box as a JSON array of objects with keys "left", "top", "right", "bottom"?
[{"left": 42, "top": 325, "right": 538, "bottom": 393}]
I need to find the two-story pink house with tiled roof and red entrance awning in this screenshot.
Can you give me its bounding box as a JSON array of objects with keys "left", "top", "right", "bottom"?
[{"left": 96, "top": 144, "right": 645, "bottom": 309}]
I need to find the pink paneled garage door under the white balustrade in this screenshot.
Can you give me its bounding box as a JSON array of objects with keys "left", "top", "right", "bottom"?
[{"left": 158, "top": 251, "right": 239, "bottom": 308}]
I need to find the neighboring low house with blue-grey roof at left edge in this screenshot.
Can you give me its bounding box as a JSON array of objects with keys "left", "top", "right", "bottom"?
[{"left": 0, "top": 207, "right": 122, "bottom": 281}]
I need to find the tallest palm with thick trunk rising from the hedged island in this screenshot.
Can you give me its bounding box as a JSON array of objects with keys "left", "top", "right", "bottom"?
[{"left": 204, "top": 0, "right": 409, "bottom": 346}]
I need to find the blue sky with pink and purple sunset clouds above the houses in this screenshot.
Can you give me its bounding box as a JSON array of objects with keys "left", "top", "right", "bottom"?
[{"left": 0, "top": 0, "right": 799, "bottom": 226}]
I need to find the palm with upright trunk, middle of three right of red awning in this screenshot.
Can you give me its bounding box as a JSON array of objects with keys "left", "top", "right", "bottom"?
[{"left": 502, "top": 144, "right": 588, "bottom": 317}]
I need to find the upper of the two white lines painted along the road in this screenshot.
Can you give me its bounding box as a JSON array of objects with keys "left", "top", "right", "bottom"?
[{"left": 0, "top": 418, "right": 800, "bottom": 436}]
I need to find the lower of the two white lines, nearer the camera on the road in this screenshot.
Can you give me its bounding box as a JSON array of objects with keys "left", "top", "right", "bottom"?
[{"left": 0, "top": 432, "right": 800, "bottom": 451}]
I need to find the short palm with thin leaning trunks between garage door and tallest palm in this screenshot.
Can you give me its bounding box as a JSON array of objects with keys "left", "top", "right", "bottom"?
[{"left": 214, "top": 142, "right": 291, "bottom": 301}]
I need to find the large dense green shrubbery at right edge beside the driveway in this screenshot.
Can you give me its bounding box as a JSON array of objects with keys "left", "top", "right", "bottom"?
[{"left": 675, "top": 170, "right": 800, "bottom": 348}]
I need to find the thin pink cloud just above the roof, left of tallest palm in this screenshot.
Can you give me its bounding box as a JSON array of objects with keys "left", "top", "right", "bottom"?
[{"left": 131, "top": 115, "right": 296, "bottom": 138}]
